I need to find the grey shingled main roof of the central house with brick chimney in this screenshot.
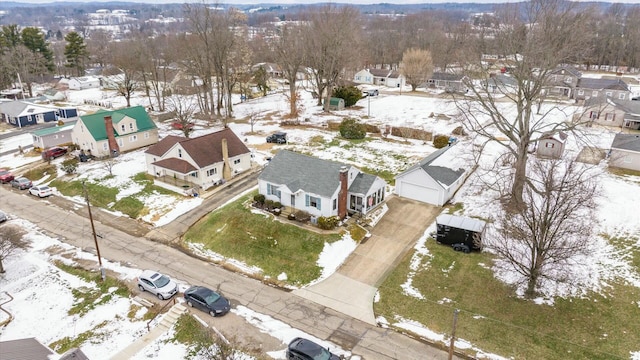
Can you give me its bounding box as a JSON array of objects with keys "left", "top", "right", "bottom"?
[{"left": 258, "top": 150, "right": 350, "bottom": 197}]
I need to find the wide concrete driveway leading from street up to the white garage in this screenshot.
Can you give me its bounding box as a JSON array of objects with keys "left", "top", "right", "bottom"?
[{"left": 294, "top": 196, "right": 442, "bottom": 324}]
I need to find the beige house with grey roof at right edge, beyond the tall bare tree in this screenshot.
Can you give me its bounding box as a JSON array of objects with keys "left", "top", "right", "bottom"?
[{"left": 580, "top": 97, "right": 640, "bottom": 130}]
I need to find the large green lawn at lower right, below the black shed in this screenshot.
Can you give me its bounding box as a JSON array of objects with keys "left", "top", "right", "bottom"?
[{"left": 374, "top": 241, "right": 640, "bottom": 360}]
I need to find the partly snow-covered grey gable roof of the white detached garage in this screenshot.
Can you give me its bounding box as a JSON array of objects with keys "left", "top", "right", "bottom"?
[{"left": 396, "top": 145, "right": 466, "bottom": 188}]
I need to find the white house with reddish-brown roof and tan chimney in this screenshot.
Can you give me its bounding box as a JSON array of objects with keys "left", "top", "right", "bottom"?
[{"left": 145, "top": 128, "right": 251, "bottom": 190}]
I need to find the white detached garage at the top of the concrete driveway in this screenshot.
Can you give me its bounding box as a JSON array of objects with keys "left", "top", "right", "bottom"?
[{"left": 395, "top": 145, "right": 470, "bottom": 206}]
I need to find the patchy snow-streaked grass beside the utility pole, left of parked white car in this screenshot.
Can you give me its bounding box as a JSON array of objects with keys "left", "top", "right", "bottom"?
[{"left": 54, "top": 261, "right": 130, "bottom": 316}]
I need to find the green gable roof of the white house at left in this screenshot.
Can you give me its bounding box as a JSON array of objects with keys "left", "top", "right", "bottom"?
[{"left": 80, "top": 106, "right": 156, "bottom": 141}]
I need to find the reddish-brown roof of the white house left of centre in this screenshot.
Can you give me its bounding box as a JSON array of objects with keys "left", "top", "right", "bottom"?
[{"left": 145, "top": 128, "right": 251, "bottom": 171}]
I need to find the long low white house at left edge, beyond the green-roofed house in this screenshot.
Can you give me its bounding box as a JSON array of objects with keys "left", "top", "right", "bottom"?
[{"left": 0, "top": 100, "right": 78, "bottom": 127}]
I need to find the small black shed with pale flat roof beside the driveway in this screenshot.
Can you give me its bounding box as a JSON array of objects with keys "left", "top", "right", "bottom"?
[{"left": 436, "top": 214, "right": 486, "bottom": 252}]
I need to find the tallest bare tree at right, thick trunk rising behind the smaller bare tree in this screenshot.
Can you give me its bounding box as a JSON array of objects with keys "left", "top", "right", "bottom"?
[{"left": 454, "top": 0, "right": 589, "bottom": 207}]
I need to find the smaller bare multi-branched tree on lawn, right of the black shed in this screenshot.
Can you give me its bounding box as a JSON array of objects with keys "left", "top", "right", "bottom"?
[{"left": 487, "top": 159, "right": 598, "bottom": 298}]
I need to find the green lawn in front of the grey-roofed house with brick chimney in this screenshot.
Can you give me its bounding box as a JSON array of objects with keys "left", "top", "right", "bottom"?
[{"left": 184, "top": 192, "right": 341, "bottom": 286}]
